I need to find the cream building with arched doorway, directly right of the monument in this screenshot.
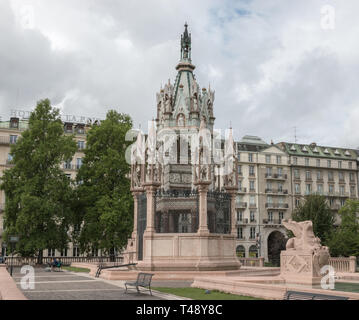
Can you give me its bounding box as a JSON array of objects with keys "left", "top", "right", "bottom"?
[{"left": 236, "top": 136, "right": 292, "bottom": 260}]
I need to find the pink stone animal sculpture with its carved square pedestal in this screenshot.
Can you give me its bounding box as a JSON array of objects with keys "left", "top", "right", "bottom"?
[{"left": 280, "top": 220, "right": 329, "bottom": 284}]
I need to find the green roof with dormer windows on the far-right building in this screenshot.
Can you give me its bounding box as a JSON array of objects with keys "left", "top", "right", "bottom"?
[{"left": 279, "top": 142, "right": 357, "bottom": 160}]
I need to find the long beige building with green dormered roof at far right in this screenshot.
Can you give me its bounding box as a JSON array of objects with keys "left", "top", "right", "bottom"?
[{"left": 278, "top": 142, "right": 358, "bottom": 224}]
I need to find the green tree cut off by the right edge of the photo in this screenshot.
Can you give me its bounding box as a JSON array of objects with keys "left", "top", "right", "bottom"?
[{"left": 328, "top": 200, "right": 359, "bottom": 257}]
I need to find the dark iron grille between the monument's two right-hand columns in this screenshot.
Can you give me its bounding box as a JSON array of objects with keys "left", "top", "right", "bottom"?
[{"left": 207, "top": 192, "right": 231, "bottom": 234}]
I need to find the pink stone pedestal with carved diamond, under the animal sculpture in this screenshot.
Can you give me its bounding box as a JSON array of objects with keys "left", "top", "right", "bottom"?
[{"left": 280, "top": 249, "right": 329, "bottom": 285}]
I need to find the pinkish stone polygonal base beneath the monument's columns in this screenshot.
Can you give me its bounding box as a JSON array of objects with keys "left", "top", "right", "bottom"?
[{"left": 136, "top": 233, "right": 241, "bottom": 271}]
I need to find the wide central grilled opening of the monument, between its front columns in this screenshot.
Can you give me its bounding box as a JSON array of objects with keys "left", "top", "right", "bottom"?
[{"left": 155, "top": 189, "right": 198, "bottom": 233}]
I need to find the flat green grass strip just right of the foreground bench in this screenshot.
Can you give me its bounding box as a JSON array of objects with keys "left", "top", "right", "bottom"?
[{"left": 153, "top": 287, "right": 262, "bottom": 300}]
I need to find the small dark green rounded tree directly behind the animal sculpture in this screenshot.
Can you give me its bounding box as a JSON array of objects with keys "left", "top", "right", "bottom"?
[{"left": 292, "top": 194, "right": 335, "bottom": 245}]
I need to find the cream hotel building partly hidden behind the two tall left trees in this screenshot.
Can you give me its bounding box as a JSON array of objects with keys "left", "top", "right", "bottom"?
[{"left": 0, "top": 117, "right": 89, "bottom": 256}]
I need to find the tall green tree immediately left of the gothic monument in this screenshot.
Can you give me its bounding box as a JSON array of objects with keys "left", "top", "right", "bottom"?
[{"left": 74, "top": 111, "right": 133, "bottom": 253}]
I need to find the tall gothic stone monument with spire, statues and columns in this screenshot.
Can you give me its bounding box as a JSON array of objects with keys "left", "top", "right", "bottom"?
[{"left": 127, "top": 24, "right": 240, "bottom": 270}]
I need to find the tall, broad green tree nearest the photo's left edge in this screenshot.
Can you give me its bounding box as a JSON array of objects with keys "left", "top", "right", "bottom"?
[{"left": 1, "top": 99, "right": 76, "bottom": 263}]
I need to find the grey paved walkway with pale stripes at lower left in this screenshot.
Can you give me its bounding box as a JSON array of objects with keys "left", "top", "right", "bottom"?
[{"left": 13, "top": 268, "right": 189, "bottom": 300}]
